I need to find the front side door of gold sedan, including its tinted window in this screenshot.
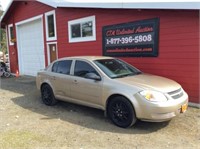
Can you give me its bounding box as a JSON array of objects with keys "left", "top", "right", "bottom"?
[{"left": 71, "top": 60, "right": 103, "bottom": 105}]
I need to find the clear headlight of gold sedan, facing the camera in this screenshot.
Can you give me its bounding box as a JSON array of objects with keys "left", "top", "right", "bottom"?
[{"left": 140, "top": 90, "right": 167, "bottom": 102}]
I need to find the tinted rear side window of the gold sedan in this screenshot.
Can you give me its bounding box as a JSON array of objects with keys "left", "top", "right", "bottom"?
[{"left": 52, "top": 60, "right": 72, "bottom": 74}]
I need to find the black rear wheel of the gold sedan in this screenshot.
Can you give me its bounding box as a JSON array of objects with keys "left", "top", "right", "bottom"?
[{"left": 41, "top": 84, "right": 57, "bottom": 106}]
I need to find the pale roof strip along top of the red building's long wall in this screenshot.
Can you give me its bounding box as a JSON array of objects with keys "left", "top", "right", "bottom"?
[{"left": 54, "top": 2, "right": 200, "bottom": 10}]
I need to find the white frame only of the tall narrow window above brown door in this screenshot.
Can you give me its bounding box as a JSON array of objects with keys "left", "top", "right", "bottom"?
[{"left": 45, "top": 10, "right": 57, "bottom": 41}]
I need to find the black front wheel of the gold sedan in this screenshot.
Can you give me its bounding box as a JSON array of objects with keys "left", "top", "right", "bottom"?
[{"left": 107, "top": 96, "right": 137, "bottom": 128}]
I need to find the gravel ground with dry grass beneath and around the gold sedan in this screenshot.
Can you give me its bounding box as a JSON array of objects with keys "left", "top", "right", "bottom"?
[{"left": 0, "top": 77, "right": 200, "bottom": 149}]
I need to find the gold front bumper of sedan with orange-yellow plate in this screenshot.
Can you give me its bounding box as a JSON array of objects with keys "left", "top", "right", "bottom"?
[{"left": 134, "top": 91, "right": 188, "bottom": 122}]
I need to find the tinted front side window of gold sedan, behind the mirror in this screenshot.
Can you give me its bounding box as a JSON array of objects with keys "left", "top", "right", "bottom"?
[{"left": 74, "top": 60, "right": 99, "bottom": 77}]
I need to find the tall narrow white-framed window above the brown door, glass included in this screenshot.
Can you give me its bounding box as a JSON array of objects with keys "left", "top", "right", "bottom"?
[{"left": 45, "top": 10, "right": 57, "bottom": 41}]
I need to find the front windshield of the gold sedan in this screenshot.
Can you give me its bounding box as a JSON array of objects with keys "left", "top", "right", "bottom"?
[{"left": 94, "top": 59, "right": 142, "bottom": 79}]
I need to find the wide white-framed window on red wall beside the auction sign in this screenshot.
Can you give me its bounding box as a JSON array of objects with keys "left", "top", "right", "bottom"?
[{"left": 68, "top": 16, "right": 96, "bottom": 42}]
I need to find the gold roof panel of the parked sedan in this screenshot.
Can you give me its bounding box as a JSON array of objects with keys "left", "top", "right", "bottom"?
[{"left": 58, "top": 56, "right": 113, "bottom": 61}]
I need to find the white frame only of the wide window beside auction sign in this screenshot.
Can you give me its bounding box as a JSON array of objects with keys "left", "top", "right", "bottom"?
[{"left": 68, "top": 16, "right": 96, "bottom": 43}]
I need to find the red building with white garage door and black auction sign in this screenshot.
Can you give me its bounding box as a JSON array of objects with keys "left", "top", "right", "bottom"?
[{"left": 1, "top": 0, "right": 200, "bottom": 105}]
